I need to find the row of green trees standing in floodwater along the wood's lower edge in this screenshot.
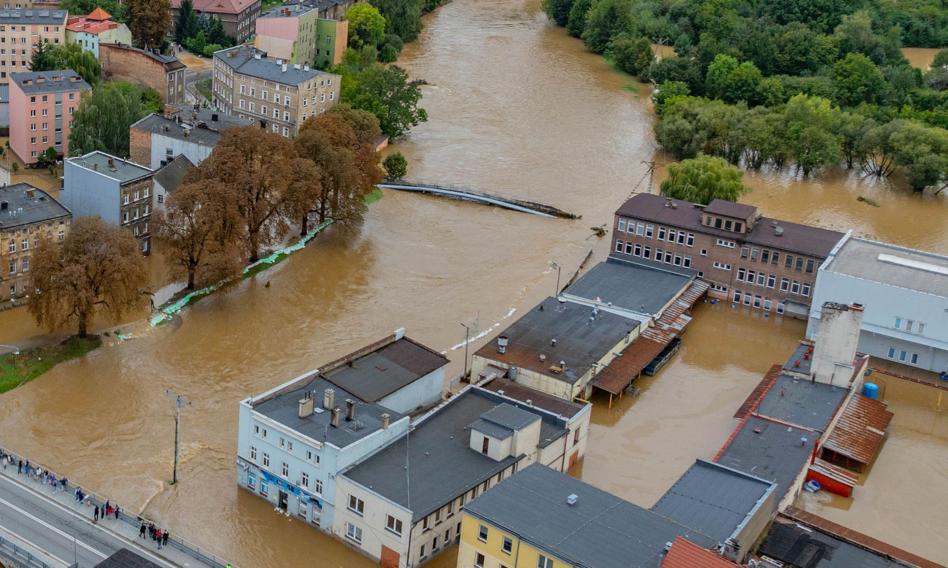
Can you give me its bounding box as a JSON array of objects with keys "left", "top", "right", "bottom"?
[{"left": 655, "top": 94, "right": 948, "bottom": 191}]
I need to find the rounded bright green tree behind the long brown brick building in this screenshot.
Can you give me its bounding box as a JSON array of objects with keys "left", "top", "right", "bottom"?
[{"left": 662, "top": 154, "right": 749, "bottom": 205}]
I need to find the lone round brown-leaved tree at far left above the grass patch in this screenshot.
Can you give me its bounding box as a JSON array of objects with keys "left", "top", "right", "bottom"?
[{"left": 29, "top": 217, "right": 147, "bottom": 337}]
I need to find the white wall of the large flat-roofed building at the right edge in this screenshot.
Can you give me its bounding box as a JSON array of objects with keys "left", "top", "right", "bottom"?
[{"left": 807, "top": 270, "right": 948, "bottom": 373}]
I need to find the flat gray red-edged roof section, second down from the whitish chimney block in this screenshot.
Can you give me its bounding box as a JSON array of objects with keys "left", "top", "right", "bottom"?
[{"left": 716, "top": 416, "right": 816, "bottom": 508}]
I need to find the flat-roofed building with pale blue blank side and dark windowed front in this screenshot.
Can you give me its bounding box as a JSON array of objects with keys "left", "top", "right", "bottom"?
[{"left": 60, "top": 151, "right": 155, "bottom": 254}]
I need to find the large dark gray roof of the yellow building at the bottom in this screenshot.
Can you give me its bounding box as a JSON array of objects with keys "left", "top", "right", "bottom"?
[{"left": 464, "top": 464, "right": 715, "bottom": 568}]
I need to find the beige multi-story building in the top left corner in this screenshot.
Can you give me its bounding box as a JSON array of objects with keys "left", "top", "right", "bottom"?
[{"left": 0, "top": 9, "right": 67, "bottom": 83}]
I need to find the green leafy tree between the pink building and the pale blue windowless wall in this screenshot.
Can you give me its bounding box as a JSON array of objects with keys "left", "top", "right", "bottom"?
[{"left": 69, "top": 82, "right": 155, "bottom": 157}]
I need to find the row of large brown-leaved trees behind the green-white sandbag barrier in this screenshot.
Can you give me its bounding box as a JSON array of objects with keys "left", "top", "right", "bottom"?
[{"left": 155, "top": 105, "right": 382, "bottom": 289}]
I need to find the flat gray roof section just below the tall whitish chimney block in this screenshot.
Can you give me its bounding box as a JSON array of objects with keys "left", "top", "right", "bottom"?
[{"left": 756, "top": 374, "right": 849, "bottom": 432}]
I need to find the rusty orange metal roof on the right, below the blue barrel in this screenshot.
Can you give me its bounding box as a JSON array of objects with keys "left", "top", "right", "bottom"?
[{"left": 823, "top": 394, "right": 894, "bottom": 464}]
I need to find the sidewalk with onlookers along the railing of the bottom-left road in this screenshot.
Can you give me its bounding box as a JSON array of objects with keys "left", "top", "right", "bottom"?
[{"left": 0, "top": 455, "right": 231, "bottom": 568}]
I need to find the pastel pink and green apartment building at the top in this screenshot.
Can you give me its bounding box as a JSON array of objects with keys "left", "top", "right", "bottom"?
[{"left": 254, "top": 0, "right": 354, "bottom": 69}]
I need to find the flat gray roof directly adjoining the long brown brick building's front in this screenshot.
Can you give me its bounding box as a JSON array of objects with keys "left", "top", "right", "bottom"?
[{"left": 563, "top": 258, "right": 695, "bottom": 315}]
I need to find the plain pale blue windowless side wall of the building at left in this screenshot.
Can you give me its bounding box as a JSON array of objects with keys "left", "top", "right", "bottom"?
[{"left": 59, "top": 160, "right": 122, "bottom": 225}]
